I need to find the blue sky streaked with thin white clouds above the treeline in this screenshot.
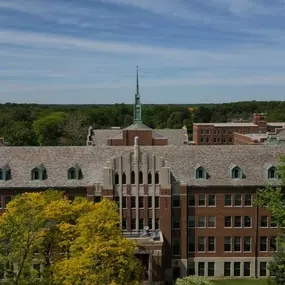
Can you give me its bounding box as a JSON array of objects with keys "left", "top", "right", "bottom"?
[{"left": 0, "top": 0, "right": 285, "bottom": 104}]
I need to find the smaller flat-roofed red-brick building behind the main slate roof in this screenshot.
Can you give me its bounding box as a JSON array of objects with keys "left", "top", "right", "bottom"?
[{"left": 193, "top": 113, "right": 285, "bottom": 145}]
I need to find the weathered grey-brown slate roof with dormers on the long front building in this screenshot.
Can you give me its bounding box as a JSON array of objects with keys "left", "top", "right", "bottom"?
[{"left": 0, "top": 145, "right": 285, "bottom": 189}]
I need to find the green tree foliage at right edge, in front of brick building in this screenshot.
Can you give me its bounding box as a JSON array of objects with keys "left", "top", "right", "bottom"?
[{"left": 255, "top": 157, "right": 285, "bottom": 285}]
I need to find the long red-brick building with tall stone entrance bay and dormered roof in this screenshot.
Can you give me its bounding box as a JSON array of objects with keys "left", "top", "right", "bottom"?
[{"left": 0, "top": 72, "right": 285, "bottom": 284}]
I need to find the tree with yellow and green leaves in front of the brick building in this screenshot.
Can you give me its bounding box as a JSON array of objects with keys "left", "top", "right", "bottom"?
[{"left": 0, "top": 190, "right": 143, "bottom": 285}]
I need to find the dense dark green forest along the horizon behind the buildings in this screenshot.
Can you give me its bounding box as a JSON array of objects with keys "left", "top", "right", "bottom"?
[{"left": 0, "top": 101, "right": 285, "bottom": 146}]
